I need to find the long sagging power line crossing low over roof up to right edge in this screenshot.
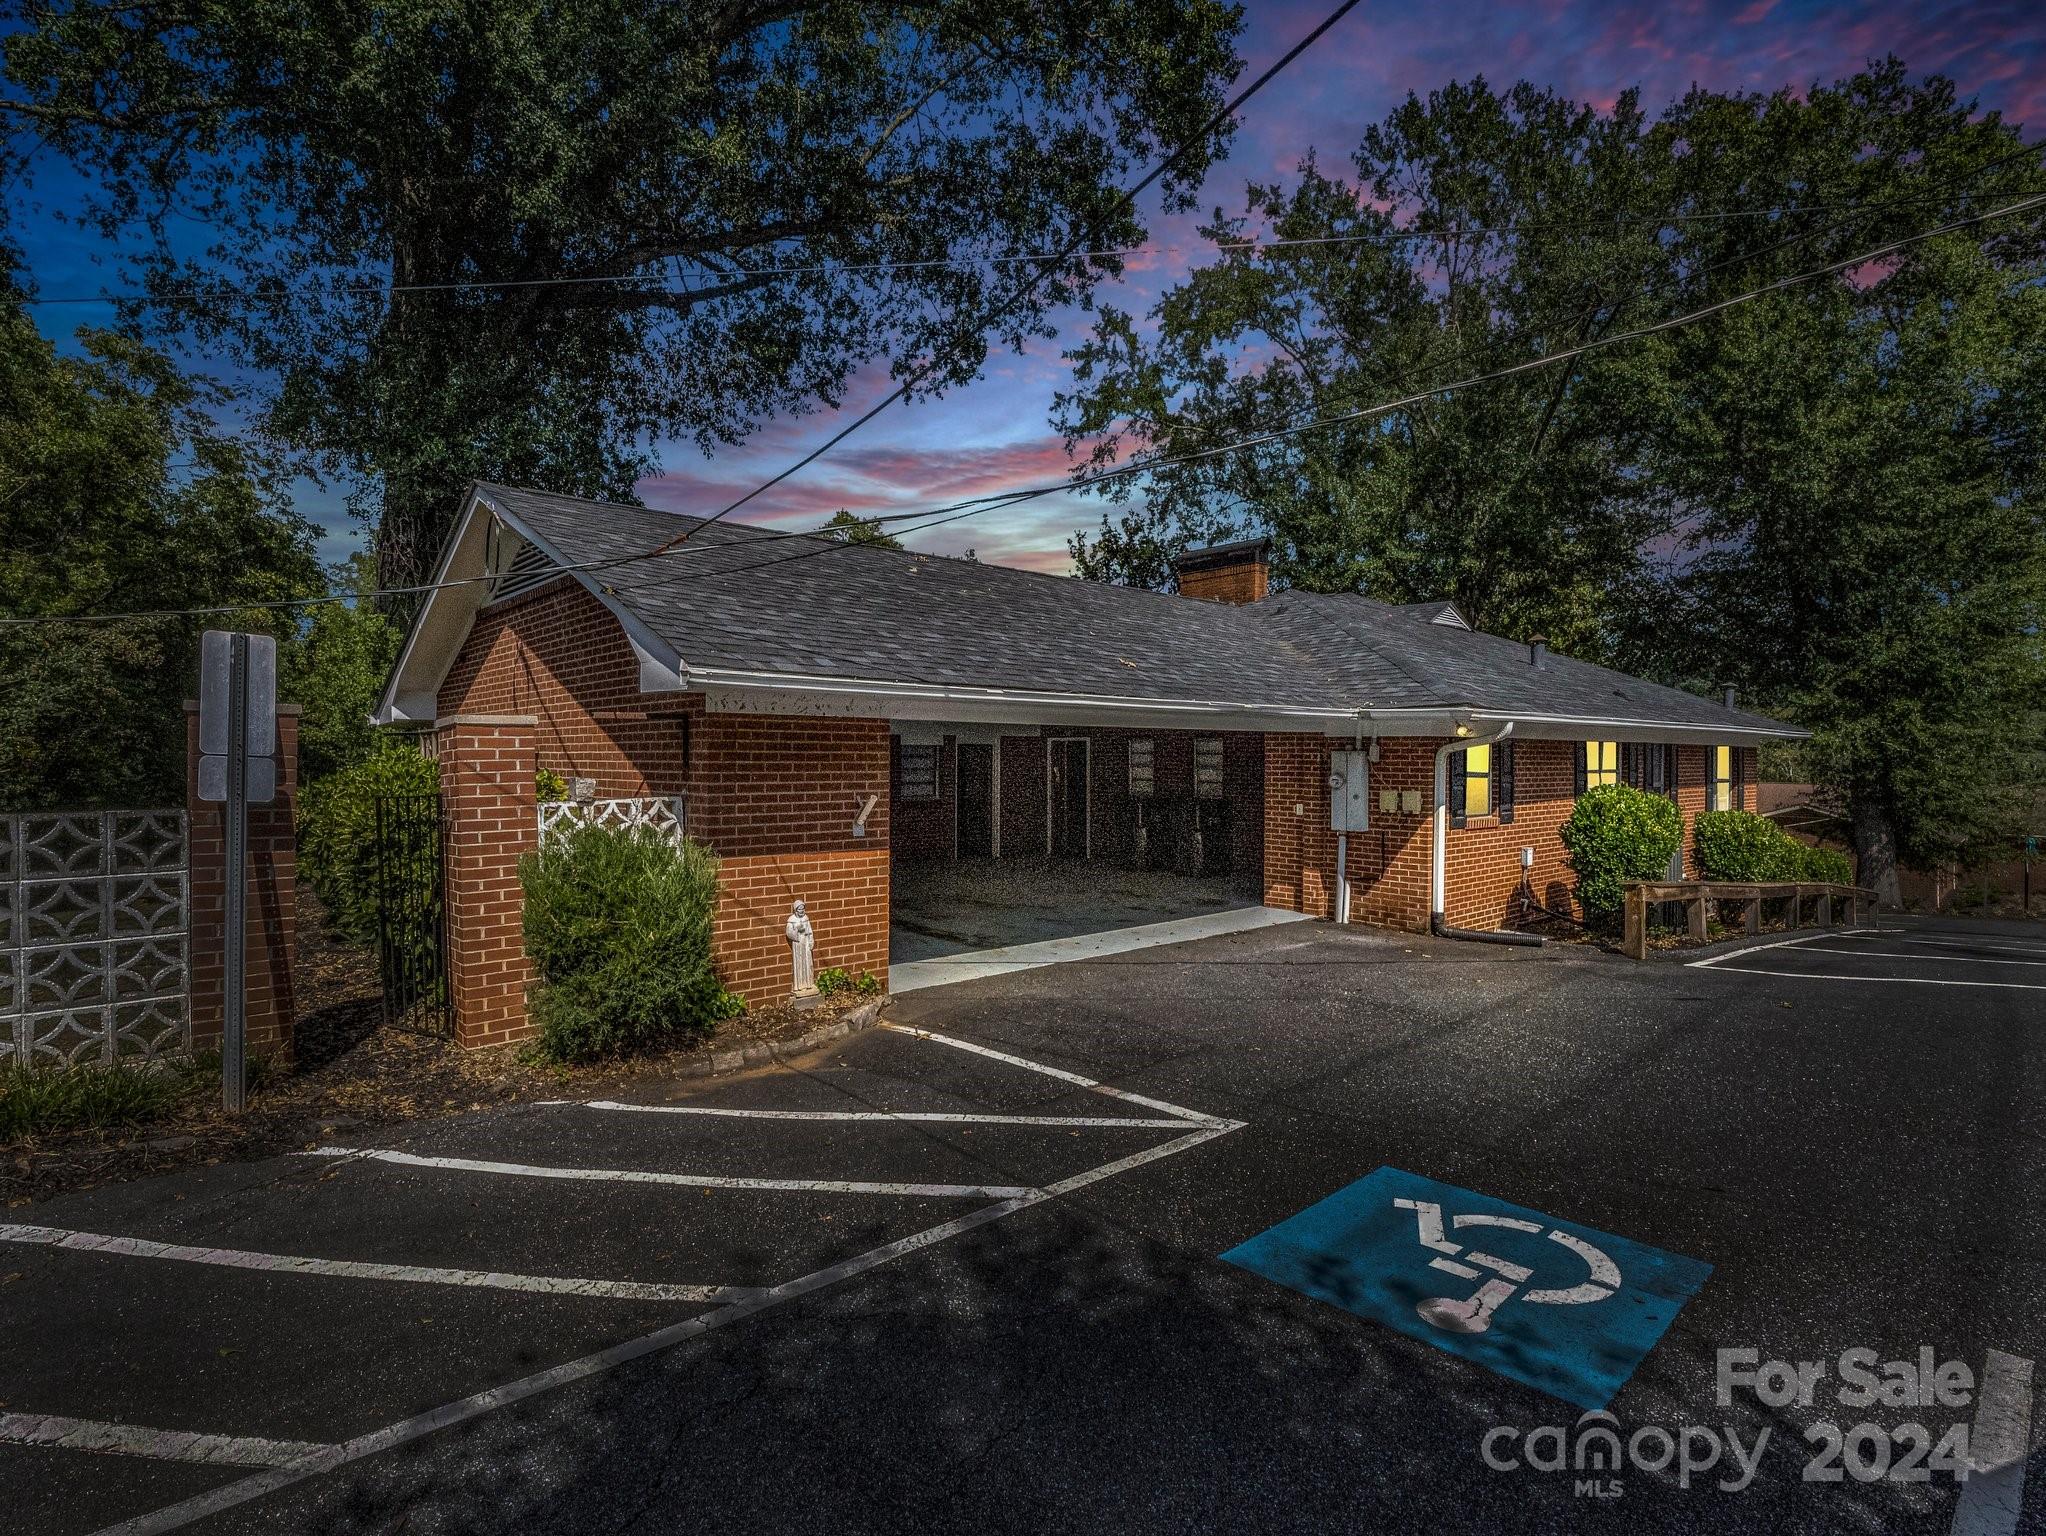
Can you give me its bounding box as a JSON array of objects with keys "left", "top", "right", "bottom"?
[{"left": 15, "top": 192, "right": 2046, "bottom": 626}]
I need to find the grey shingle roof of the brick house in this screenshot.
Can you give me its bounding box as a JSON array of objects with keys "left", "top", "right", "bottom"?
[{"left": 477, "top": 485, "right": 1782, "bottom": 730}]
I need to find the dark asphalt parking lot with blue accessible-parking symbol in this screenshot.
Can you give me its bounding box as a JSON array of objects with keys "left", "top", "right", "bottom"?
[{"left": 0, "top": 920, "right": 2046, "bottom": 1536}]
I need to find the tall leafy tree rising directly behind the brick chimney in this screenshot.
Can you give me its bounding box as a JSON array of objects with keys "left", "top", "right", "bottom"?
[{"left": 1058, "top": 80, "right": 1661, "bottom": 648}]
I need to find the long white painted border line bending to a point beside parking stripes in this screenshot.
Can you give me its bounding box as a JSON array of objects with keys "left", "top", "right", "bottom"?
[{"left": 98, "top": 1031, "right": 1244, "bottom": 1536}]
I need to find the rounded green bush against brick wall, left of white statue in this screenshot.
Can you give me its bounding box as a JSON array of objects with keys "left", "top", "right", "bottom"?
[{"left": 520, "top": 826, "right": 745, "bottom": 1061}]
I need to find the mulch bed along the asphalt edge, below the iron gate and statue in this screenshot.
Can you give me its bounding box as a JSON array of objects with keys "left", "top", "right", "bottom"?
[{"left": 0, "top": 888, "right": 887, "bottom": 1207}]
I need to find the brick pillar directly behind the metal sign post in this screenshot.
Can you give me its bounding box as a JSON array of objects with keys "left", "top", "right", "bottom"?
[{"left": 184, "top": 699, "right": 299, "bottom": 1057}]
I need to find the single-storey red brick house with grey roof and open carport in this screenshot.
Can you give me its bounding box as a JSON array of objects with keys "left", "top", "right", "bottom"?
[{"left": 376, "top": 485, "right": 1803, "bottom": 1038}]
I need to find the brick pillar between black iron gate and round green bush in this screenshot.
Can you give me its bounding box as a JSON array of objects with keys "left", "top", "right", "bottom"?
[{"left": 434, "top": 714, "right": 540, "bottom": 1045}]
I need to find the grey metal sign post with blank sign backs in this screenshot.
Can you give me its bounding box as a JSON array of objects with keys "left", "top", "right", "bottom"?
[{"left": 198, "top": 630, "right": 276, "bottom": 1115}]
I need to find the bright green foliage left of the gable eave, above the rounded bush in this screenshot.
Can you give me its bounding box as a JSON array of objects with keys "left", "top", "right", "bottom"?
[{"left": 278, "top": 554, "right": 403, "bottom": 783}]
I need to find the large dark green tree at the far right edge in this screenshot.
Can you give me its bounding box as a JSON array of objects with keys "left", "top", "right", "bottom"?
[{"left": 1631, "top": 63, "right": 2046, "bottom": 902}]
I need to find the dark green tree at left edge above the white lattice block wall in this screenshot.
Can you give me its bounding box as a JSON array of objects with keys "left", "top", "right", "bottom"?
[{"left": 0, "top": 280, "right": 319, "bottom": 810}]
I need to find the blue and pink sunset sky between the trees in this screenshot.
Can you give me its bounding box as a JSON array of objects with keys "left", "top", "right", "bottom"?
[{"left": 20, "top": 0, "right": 2046, "bottom": 571}]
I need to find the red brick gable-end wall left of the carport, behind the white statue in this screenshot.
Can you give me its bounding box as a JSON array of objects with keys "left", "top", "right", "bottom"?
[{"left": 440, "top": 581, "right": 892, "bottom": 1014}]
